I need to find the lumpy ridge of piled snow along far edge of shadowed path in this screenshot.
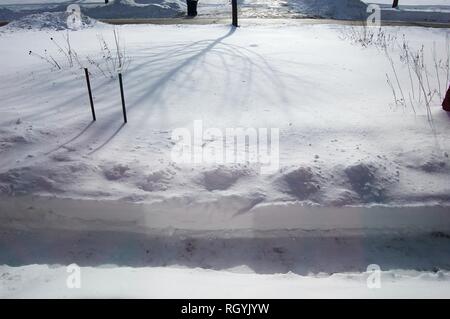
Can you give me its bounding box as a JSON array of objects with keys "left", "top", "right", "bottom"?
[{"left": 0, "top": 158, "right": 442, "bottom": 206}]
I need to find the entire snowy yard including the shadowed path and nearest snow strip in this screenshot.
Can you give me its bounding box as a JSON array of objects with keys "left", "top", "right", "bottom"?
[{"left": 0, "top": 5, "right": 450, "bottom": 298}]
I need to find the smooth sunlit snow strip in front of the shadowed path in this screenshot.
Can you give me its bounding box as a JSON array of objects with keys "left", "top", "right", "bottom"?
[{"left": 0, "top": 265, "right": 450, "bottom": 299}]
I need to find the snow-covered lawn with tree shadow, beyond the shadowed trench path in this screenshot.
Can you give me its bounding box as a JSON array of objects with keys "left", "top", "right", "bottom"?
[{"left": 0, "top": 21, "right": 450, "bottom": 210}]
